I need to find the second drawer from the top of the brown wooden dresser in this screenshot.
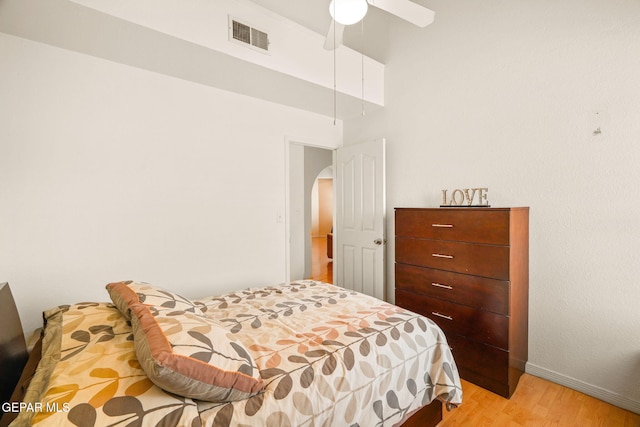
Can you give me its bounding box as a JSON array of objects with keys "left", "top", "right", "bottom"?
[{"left": 396, "top": 237, "right": 509, "bottom": 280}]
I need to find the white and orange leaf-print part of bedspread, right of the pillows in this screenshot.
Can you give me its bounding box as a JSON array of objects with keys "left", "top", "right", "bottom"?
[{"left": 195, "top": 281, "right": 462, "bottom": 427}]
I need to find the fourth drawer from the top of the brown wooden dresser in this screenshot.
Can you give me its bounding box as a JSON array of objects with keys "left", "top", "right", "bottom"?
[{"left": 396, "top": 289, "right": 509, "bottom": 349}]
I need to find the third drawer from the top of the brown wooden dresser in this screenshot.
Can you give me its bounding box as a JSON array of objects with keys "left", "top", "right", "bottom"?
[{"left": 396, "top": 264, "right": 509, "bottom": 315}]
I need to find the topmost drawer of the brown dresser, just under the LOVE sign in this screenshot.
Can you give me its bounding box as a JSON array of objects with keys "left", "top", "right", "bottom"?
[{"left": 396, "top": 208, "right": 509, "bottom": 245}]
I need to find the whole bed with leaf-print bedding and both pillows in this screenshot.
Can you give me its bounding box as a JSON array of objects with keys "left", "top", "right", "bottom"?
[{"left": 2, "top": 281, "right": 462, "bottom": 427}]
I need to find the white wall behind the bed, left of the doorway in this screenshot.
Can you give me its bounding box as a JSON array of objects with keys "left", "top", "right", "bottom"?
[{"left": 0, "top": 33, "right": 341, "bottom": 331}]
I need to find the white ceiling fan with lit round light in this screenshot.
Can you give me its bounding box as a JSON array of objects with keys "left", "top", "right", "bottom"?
[{"left": 324, "top": 0, "right": 435, "bottom": 50}]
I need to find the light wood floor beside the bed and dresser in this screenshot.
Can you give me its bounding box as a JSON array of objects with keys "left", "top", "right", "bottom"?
[{"left": 438, "top": 374, "right": 640, "bottom": 427}]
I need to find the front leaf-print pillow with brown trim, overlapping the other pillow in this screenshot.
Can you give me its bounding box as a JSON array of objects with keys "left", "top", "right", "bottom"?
[{"left": 109, "top": 285, "right": 264, "bottom": 402}]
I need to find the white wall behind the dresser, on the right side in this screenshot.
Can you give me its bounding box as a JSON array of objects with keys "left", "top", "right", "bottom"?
[{"left": 345, "top": 0, "right": 640, "bottom": 412}]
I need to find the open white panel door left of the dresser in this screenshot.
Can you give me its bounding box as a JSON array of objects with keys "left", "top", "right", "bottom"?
[{"left": 334, "top": 140, "right": 385, "bottom": 299}]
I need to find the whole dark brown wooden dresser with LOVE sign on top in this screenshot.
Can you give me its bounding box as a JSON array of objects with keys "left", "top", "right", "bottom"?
[{"left": 395, "top": 208, "right": 529, "bottom": 397}]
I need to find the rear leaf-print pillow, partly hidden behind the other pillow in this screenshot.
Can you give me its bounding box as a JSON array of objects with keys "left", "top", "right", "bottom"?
[{"left": 107, "top": 280, "right": 202, "bottom": 319}]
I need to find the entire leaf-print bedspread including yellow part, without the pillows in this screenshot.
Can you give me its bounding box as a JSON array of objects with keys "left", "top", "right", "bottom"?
[{"left": 11, "top": 281, "right": 462, "bottom": 427}]
